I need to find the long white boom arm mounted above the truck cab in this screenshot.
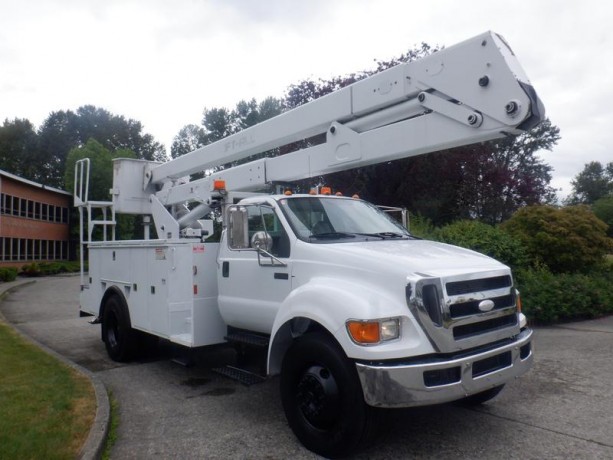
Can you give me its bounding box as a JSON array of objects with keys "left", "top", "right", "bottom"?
[{"left": 107, "top": 32, "right": 544, "bottom": 236}]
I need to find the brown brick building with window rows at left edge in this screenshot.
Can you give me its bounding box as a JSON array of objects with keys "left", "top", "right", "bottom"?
[{"left": 0, "top": 170, "right": 72, "bottom": 267}]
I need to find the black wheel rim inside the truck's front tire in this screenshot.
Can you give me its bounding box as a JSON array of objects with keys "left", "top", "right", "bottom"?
[{"left": 296, "top": 365, "right": 340, "bottom": 430}]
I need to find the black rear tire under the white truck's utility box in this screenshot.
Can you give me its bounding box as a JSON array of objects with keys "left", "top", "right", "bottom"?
[{"left": 102, "top": 295, "right": 138, "bottom": 362}]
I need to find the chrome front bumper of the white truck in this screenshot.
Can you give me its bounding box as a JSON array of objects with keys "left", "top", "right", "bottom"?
[{"left": 356, "top": 329, "right": 533, "bottom": 407}]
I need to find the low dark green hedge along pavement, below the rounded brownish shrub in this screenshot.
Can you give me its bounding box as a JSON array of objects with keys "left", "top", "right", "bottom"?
[{"left": 515, "top": 268, "right": 613, "bottom": 324}]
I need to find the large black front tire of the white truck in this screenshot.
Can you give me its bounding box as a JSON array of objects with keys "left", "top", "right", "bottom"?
[{"left": 281, "top": 333, "right": 375, "bottom": 458}]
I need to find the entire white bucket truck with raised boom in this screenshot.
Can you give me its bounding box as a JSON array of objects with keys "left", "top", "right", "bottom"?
[{"left": 75, "top": 32, "right": 544, "bottom": 457}]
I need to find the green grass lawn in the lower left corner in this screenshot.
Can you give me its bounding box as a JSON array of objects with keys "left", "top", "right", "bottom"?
[{"left": 0, "top": 321, "right": 96, "bottom": 459}]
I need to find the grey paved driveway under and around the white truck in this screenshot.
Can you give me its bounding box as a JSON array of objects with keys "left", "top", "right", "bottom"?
[{"left": 0, "top": 277, "right": 613, "bottom": 459}]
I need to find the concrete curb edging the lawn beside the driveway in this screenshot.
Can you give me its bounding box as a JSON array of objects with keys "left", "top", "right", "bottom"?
[{"left": 0, "top": 280, "right": 111, "bottom": 460}]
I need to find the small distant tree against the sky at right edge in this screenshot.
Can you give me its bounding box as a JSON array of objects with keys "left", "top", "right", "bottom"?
[{"left": 568, "top": 161, "right": 613, "bottom": 204}]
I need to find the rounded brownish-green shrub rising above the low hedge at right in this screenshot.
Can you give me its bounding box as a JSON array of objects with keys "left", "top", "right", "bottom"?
[{"left": 502, "top": 206, "right": 612, "bottom": 273}]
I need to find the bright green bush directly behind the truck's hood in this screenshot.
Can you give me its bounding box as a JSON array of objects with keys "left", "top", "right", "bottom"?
[{"left": 434, "top": 220, "right": 528, "bottom": 269}]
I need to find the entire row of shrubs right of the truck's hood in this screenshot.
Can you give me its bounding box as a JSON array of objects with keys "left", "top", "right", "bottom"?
[{"left": 429, "top": 212, "right": 613, "bottom": 324}]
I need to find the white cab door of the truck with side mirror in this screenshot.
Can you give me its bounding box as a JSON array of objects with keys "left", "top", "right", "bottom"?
[{"left": 218, "top": 204, "right": 292, "bottom": 333}]
